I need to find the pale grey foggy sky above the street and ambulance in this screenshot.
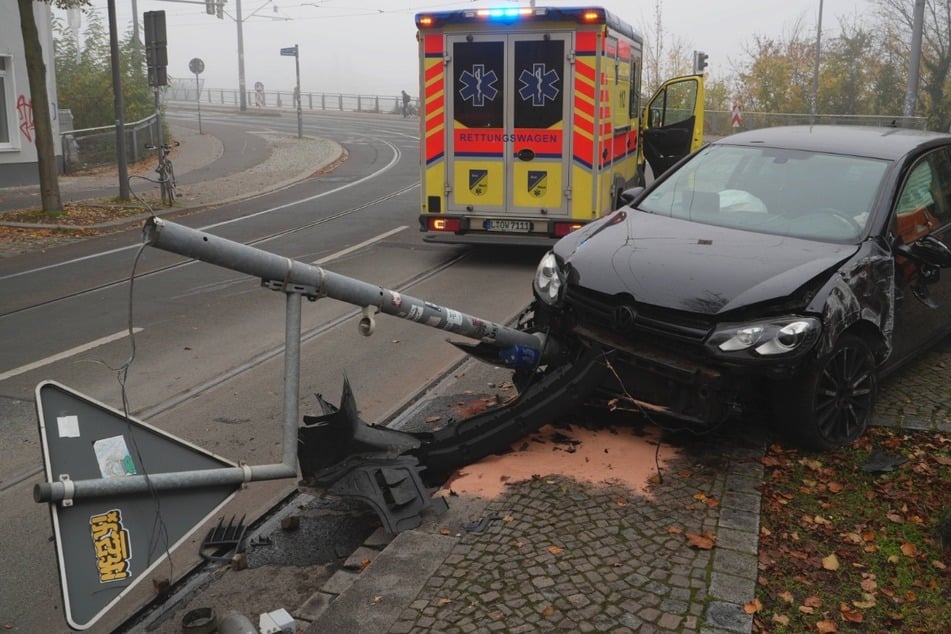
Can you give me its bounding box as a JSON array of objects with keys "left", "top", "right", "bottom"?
[{"left": 57, "top": 0, "right": 875, "bottom": 95}]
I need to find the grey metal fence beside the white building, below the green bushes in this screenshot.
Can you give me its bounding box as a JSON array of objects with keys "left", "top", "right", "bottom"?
[{"left": 61, "top": 114, "right": 162, "bottom": 174}]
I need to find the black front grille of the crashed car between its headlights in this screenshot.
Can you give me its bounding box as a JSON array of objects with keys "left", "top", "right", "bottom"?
[{"left": 566, "top": 286, "right": 715, "bottom": 345}]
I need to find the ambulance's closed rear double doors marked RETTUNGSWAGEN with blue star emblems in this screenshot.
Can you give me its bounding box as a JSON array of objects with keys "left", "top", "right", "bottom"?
[{"left": 447, "top": 31, "right": 572, "bottom": 232}]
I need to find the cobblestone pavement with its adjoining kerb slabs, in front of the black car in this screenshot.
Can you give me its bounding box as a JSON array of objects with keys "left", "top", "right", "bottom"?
[{"left": 308, "top": 408, "right": 765, "bottom": 634}]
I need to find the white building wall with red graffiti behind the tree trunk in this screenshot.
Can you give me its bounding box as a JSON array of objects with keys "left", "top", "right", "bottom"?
[{"left": 0, "top": 1, "right": 63, "bottom": 187}]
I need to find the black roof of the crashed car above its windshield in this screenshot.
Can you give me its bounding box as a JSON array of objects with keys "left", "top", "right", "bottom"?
[{"left": 714, "top": 125, "right": 951, "bottom": 160}]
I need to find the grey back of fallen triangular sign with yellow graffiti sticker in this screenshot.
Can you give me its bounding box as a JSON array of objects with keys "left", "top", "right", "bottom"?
[{"left": 36, "top": 381, "right": 240, "bottom": 630}]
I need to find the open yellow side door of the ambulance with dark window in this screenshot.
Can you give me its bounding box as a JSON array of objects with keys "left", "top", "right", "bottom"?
[{"left": 637, "top": 75, "right": 703, "bottom": 183}]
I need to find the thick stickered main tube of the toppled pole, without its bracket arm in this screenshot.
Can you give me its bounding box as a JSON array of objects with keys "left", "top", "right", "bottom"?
[{"left": 143, "top": 216, "right": 557, "bottom": 366}]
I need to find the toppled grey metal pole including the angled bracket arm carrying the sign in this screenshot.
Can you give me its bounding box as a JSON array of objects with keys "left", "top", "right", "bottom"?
[{"left": 33, "top": 216, "right": 555, "bottom": 503}]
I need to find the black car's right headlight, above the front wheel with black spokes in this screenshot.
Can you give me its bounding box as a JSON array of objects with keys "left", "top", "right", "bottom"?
[{"left": 707, "top": 317, "right": 822, "bottom": 357}]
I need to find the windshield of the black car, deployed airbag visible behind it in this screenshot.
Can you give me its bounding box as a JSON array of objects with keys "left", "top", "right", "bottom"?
[{"left": 638, "top": 145, "right": 888, "bottom": 242}]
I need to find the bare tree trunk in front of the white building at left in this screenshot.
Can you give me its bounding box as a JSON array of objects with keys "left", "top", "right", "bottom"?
[{"left": 17, "top": 0, "right": 63, "bottom": 212}]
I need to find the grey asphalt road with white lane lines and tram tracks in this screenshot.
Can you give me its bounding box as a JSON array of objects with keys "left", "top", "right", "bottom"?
[{"left": 0, "top": 113, "right": 540, "bottom": 632}]
